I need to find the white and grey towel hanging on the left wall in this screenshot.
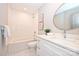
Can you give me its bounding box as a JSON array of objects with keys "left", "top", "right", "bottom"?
[{"left": 0, "top": 25, "right": 11, "bottom": 48}]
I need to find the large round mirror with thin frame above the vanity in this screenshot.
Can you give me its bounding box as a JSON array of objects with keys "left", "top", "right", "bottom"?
[{"left": 53, "top": 3, "right": 79, "bottom": 31}]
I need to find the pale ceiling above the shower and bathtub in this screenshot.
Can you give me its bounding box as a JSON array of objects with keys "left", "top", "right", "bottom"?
[{"left": 8, "top": 3, "right": 45, "bottom": 14}]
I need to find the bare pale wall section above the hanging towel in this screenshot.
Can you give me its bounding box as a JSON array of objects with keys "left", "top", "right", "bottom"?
[{"left": 0, "top": 3, "right": 8, "bottom": 25}]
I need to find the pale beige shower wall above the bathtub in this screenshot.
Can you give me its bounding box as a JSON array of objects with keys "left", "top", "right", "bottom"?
[{"left": 8, "top": 7, "right": 34, "bottom": 43}]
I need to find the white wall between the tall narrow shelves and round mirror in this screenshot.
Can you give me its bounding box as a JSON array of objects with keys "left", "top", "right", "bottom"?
[{"left": 40, "top": 3, "right": 63, "bottom": 32}]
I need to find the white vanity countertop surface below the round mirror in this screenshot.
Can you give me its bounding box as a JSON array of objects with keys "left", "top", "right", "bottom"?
[{"left": 37, "top": 35, "right": 79, "bottom": 53}]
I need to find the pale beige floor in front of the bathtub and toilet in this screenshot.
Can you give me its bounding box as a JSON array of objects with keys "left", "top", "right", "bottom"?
[{"left": 7, "top": 48, "right": 35, "bottom": 56}]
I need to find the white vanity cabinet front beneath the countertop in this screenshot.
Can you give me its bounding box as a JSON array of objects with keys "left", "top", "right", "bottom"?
[{"left": 37, "top": 37, "right": 79, "bottom": 56}]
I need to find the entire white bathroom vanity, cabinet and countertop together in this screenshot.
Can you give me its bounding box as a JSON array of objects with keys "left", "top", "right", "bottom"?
[{"left": 36, "top": 34, "right": 79, "bottom": 56}]
